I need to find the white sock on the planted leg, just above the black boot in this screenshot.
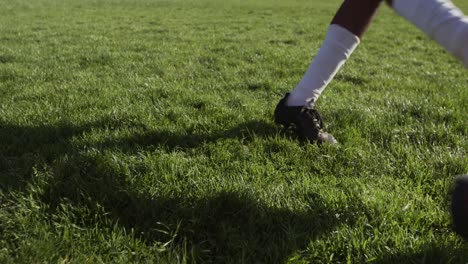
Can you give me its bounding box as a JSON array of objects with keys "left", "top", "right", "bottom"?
[{"left": 286, "top": 24, "right": 360, "bottom": 106}]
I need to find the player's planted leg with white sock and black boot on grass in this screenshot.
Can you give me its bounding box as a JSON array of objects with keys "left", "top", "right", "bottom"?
[{"left": 275, "top": 0, "right": 382, "bottom": 143}]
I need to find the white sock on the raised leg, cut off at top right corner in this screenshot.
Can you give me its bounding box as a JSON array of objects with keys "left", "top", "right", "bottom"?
[{"left": 393, "top": 0, "right": 468, "bottom": 68}]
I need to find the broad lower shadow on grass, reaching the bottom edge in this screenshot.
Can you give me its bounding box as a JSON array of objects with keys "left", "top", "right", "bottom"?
[{"left": 42, "top": 154, "right": 358, "bottom": 263}]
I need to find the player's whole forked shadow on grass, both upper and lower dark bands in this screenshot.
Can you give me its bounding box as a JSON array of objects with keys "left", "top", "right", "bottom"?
[{"left": 0, "top": 118, "right": 348, "bottom": 263}]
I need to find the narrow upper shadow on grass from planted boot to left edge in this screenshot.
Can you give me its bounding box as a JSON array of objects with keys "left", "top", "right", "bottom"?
[{"left": 0, "top": 119, "right": 278, "bottom": 189}]
